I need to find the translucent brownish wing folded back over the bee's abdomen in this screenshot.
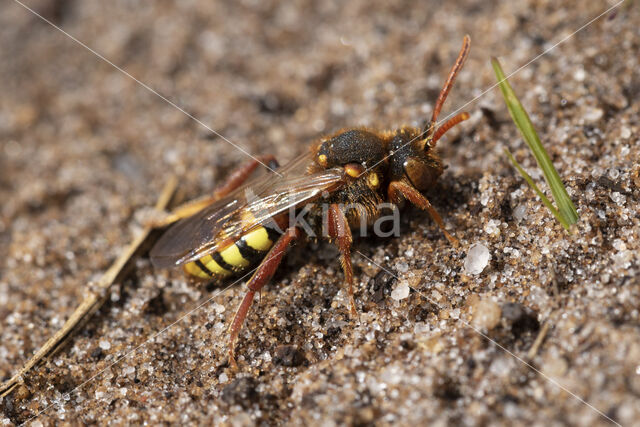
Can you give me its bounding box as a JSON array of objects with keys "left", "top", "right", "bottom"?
[{"left": 150, "top": 154, "right": 345, "bottom": 268}]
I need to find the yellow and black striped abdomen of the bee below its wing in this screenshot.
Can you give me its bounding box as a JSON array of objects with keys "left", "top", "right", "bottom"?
[{"left": 184, "top": 226, "right": 280, "bottom": 279}]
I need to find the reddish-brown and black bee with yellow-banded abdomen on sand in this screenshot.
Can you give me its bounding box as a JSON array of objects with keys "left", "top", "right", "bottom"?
[{"left": 150, "top": 36, "right": 470, "bottom": 369}]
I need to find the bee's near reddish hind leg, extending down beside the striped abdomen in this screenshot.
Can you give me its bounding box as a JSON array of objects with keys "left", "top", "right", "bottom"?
[{"left": 229, "top": 227, "right": 301, "bottom": 370}]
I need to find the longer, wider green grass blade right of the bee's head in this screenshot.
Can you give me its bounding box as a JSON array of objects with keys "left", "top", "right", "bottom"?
[{"left": 491, "top": 58, "right": 578, "bottom": 228}]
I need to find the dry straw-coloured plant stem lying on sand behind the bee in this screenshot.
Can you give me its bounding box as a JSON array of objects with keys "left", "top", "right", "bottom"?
[{"left": 0, "top": 177, "right": 177, "bottom": 397}]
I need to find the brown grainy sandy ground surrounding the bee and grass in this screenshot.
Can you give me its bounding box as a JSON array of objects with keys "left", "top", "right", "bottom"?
[{"left": 0, "top": 0, "right": 640, "bottom": 426}]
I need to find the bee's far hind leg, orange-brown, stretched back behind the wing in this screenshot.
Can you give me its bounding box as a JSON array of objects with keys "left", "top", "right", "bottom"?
[{"left": 152, "top": 155, "right": 278, "bottom": 228}]
